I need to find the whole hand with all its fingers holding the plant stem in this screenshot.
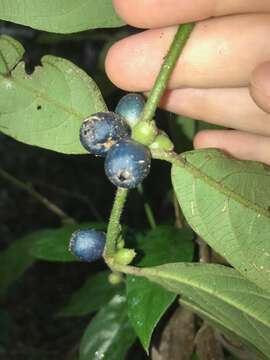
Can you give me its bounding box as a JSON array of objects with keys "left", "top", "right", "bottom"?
[{"left": 106, "top": 0, "right": 270, "bottom": 165}]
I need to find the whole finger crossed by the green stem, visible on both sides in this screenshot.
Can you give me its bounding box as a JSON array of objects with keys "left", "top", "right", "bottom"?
[{"left": 106, "top": 14, "right": 270, "bottom": 91}]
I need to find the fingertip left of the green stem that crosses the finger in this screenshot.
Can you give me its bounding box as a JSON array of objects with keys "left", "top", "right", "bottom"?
[{"left": 105, "top": 27, "right": 172, "bottom": 92}]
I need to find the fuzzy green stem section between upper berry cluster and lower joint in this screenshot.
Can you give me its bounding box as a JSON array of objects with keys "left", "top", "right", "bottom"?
[{"left": 105, "top": 188, "right": 128, "bottom": 257}]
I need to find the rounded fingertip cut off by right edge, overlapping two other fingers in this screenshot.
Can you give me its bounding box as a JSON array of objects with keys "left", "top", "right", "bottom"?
[{"left": 249, "top": 61, "right": 270, "bottom": 113}]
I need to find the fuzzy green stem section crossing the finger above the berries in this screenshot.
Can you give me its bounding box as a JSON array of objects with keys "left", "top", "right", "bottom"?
[{"left": 141, "top": 23, "right": 194, "bottom": 121}]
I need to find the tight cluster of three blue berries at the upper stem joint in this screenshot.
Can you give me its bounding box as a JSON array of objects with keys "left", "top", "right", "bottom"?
[{"left": 80, "top": 94, "right": 151, "bottom": 189}]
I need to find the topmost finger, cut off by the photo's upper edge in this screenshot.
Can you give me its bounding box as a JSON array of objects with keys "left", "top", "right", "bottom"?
[{"left": 114, "top": 0, "right": 270, "bottom": 28}]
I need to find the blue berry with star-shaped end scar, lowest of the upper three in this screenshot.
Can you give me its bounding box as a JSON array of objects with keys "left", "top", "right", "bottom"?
[{"left": 105, "top": 139, "right": 151, "bottom": 189}]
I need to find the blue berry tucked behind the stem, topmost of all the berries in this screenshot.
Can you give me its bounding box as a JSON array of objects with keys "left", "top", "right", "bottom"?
[{"left": 115, "top": 93, "right": 145, "bottom": 127}]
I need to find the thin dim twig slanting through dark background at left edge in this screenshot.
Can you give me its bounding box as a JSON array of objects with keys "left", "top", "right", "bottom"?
[{"left": 0, "top": 169, "right": 76, "bottom": 224}]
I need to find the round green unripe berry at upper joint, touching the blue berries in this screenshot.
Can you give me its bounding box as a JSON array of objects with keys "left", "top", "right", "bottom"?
[{"left": 132, "top": 121, "right": 158, "bottom": 146}]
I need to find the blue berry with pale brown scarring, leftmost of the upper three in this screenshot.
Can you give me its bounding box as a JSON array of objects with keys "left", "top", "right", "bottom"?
[{"left": 80, "top": 111, "right": 131, "bottom": 156}]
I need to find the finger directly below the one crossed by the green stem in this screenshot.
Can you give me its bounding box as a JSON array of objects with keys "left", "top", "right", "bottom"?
[{"left": 160, "top": 88, "right": 270, "bottom": 135}]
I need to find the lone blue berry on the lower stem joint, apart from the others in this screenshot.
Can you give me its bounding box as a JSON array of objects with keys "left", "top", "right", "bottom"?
[{"left": 69, "top": 229, "right": 106, "bottom": 262}]
